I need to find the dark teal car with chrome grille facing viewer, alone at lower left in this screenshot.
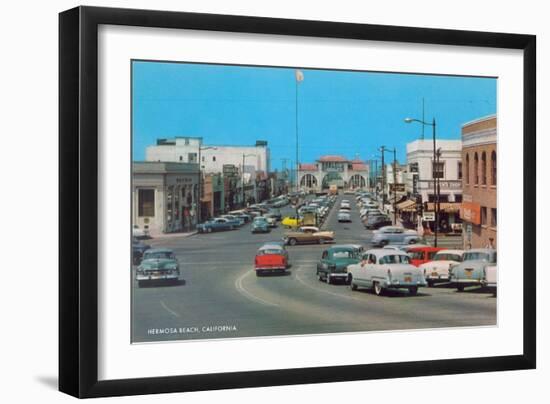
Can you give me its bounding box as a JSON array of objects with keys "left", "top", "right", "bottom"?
[{"left": 136, "top": 248, "right": 180, "bottom": 286}]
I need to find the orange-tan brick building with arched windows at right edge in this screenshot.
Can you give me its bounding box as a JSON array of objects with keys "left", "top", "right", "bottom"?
[{"left": 460, "top": 115, "right": 497, "bottom": 248}]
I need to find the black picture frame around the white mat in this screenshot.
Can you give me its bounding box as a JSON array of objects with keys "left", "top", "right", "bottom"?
[{"left": 59, "top": 7, "right": 536, "bottom": 398}]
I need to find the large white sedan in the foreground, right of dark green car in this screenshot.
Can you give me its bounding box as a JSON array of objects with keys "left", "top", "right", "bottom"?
[{"left": 348, "top": 248, "right": 426, "bottom": 296}]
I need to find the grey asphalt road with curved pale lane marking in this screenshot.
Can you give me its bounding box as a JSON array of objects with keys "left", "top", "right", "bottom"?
[{"left": 132, "top": 195, "right": 496, "bottom": 342}]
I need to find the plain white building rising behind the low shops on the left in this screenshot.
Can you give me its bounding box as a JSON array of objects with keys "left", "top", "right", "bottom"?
[{"left": 145, "top": 136, "right": 270, "bottom": 176}]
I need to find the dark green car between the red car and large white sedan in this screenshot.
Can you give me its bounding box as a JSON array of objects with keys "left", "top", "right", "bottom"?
[{"left": 317, "top": 245, "right": 361, "bottom": 284}]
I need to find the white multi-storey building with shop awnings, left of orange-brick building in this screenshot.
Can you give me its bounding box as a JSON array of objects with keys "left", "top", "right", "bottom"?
[{"left": 405, "top": 139, "right": 462, "bottom": 223}]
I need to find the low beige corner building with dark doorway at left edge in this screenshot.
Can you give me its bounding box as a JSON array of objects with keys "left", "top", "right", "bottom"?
[{"left": 132, "top": 162, "right": 199, "bottom": 236}]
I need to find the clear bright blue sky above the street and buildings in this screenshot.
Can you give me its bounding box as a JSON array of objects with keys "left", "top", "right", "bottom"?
[{"left": 132, "top": 61, "right": 497, "bottom": 169}]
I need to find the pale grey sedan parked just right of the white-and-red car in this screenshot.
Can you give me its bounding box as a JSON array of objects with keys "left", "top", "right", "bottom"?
[{"left": 451, "top": 248, "right": 497, "bottom": 292}]
